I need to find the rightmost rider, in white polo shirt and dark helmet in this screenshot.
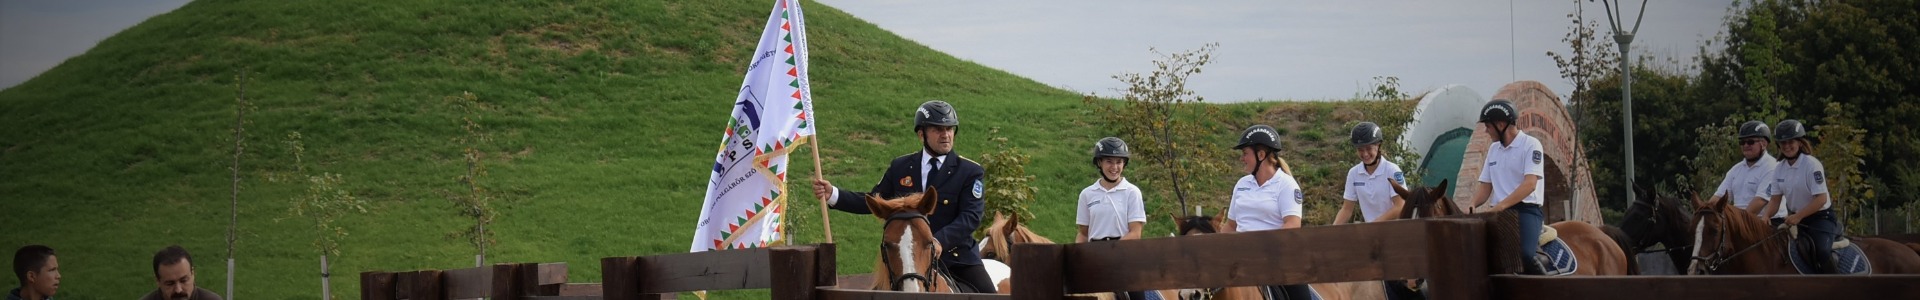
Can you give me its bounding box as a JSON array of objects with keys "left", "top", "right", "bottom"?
[{"left": 1766, "top": 119, "right": 1841, "bottom": 273}]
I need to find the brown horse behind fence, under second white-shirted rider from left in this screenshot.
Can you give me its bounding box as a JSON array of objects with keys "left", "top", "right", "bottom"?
[{"left": 1160, "top": 213, "right": 1386, "bottom": 300}]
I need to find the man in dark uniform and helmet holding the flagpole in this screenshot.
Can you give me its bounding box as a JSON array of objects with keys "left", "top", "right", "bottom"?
[{"left": 814, "top": 100, "right": 995, "bottom": 294}]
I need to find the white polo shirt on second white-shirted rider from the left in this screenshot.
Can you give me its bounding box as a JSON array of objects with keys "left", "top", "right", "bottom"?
[{"left": 1227, "top": 171, "right": 1306, "bottom": 231}]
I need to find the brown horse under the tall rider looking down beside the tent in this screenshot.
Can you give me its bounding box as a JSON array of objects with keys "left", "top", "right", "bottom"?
[{"left": 1400, "top": 181, "right": 1640, "bottom": 275}]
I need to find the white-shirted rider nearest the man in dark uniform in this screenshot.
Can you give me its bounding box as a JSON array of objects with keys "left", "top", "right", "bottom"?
[{"left": 1073, "top": 137, "right": 1146, "bottom": 300}]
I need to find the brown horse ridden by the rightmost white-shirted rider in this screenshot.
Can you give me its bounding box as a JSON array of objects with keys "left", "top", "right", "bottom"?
[{"left": 1688, "top": 202, "right": 1920, "bottom": 275}]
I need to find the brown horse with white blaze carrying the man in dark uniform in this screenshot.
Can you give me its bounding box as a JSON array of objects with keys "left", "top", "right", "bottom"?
[{"left": 866, "top": 187, "right": 954, "bottom": 292}]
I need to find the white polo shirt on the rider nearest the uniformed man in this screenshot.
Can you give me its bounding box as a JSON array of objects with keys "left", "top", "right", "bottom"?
[{"left": 1073, "top": 179, "right": 1146, "bottom": 240}]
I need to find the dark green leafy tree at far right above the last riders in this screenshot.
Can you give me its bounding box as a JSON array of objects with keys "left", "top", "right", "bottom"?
[{"left": 1699, "top": 0, "right": 1920, "bottom": 216}]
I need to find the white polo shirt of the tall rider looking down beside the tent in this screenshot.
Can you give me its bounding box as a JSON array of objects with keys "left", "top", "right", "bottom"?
[{"left": 1480, "top": 129, "right": 1548, "bottom": 206}]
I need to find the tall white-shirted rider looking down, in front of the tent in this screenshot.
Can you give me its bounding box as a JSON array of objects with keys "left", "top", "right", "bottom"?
[{"left": 1473, "top": 100, "right": 1546, "bottom": 275}]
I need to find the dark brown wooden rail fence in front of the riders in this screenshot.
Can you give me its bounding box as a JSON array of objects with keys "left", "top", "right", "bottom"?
[{"left": 361, "top": 215, "right": 1920, "bottom": 300}]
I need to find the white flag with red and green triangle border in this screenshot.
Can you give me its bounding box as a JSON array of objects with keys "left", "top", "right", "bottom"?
[{"left": 691, "top": 0, "right": 814, "bottom": 252}]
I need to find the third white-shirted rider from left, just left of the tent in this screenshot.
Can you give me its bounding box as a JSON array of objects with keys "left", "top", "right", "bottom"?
[{"left": 1332, "top": 121, "right": 1407, "bottom": 225}]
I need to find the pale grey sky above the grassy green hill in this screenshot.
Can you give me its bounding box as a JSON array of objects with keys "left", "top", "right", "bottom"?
[{"left": 0, "top": 0, "right": 1732, "bottom": 102}]
